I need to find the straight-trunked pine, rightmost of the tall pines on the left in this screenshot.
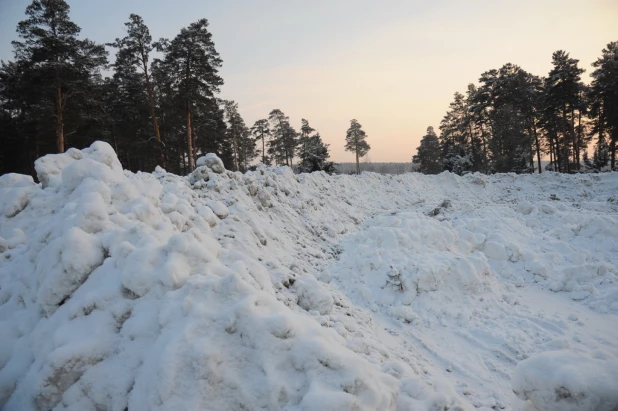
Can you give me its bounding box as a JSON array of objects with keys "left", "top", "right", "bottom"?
[{"left": 158, "top": 19, "right": 223, "bottom": 171}]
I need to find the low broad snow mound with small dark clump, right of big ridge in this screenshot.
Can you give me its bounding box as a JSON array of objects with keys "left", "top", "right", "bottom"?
[{"left": 334, "top": 212, "right": 498, "bottom": 321}]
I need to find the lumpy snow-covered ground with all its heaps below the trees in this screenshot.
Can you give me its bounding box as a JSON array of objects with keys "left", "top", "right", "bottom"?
[{"left": 0, "top": 142, "right": 618, "bottom": 411}]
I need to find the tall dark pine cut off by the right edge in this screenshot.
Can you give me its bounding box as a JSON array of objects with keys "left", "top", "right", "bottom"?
[{"left": 589, "top": 41, "right": 618, "bottom": 170}]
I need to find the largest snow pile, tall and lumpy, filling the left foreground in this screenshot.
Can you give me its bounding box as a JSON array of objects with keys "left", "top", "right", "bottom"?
[{"left": 0, "top": 143, "right": 397, "bottom": 410}]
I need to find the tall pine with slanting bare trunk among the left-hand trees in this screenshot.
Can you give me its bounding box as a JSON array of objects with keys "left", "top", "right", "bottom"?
[{"left": 110, "top": 14, "right": 164, "bottom": 164}]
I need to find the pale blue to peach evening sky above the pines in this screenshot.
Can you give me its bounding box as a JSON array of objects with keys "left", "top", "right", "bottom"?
[{"left": 0, "top": 0, "right": 618, "bottom": 162}]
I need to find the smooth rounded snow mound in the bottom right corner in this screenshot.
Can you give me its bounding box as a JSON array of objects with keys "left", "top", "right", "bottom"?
[{"left": 513, "top": 351, "right": 618, "bottom": 411}]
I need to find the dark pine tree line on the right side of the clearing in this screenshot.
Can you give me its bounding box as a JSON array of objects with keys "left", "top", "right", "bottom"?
[{"left": 412, "top": 42, "right": 618, "bottom": 174}]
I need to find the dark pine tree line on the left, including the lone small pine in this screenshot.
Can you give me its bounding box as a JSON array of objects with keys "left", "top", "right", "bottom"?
[{"left": 0, "top": 0, "right": 376, "bottom": 175}]
